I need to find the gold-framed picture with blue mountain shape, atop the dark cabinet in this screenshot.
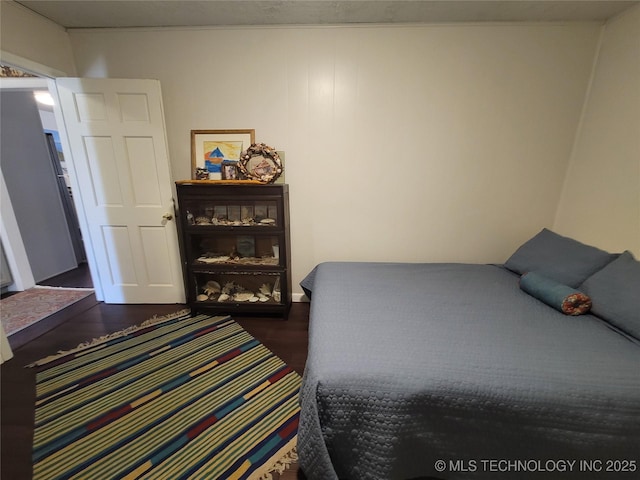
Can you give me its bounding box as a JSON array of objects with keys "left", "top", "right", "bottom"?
[{"left": 191, "top": 129, "right": 256, "bottom": 180}]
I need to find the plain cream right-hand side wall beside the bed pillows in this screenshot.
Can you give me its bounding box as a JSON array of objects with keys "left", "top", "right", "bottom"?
[{"left": 554, "top": 7, "right": 640, "bottom": 256}]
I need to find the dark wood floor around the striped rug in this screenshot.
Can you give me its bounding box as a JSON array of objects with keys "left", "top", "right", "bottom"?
[{"left": 0, "top": 266, "right": 309, "bottom": 480}]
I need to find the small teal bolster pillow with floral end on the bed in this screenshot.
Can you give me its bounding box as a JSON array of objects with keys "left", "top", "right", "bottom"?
[{"left": 520, "top": 272, "right": 591, "bottom": 315}]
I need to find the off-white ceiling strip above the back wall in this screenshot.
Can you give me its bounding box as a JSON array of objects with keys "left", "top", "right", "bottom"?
[{"left": 17, "top": 0, "right": 640, "bottom": 28}]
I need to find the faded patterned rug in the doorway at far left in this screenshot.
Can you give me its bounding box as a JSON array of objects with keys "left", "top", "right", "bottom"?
[{"left": 0, "top": 285, "right": 93, "bottom": 335}]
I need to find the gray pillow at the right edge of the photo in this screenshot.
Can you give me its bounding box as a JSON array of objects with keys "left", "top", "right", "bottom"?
[{"left": 580, "top": 251, "right": 640, "bottom": 340}]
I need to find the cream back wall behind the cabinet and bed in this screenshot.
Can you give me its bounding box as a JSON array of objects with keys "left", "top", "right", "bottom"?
[{"left": 70, "top": 24, "right": 601, "bottom": 288}]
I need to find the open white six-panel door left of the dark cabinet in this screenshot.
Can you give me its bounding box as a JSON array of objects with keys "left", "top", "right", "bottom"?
[{"left": 56, "top": 78, "right": 184, "bottom": 303}]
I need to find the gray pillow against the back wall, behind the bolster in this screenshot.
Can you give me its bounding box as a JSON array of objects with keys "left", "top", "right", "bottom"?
[{"left": 505, "top": 228, "right": 616, "bottom": 288}]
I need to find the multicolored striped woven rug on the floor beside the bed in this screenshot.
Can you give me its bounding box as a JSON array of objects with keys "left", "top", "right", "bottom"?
[{"left": 33, "top": 314, "right": 300, "bottom": 480}]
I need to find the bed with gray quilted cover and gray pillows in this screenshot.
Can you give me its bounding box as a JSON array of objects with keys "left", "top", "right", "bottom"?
[{"left": 298, "top": 229, "right": 640, "bottom": 480}]
